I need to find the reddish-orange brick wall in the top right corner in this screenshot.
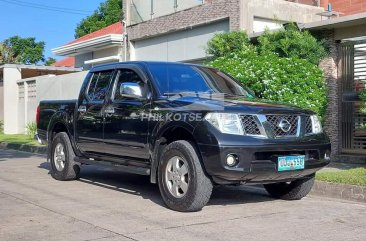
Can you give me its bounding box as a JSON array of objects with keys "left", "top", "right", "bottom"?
[{"left": 329, "top": 0, "right": 366, "bottom": 15}]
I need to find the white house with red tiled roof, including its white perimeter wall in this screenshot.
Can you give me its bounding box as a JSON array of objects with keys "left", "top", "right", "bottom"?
[{"left": 0, "top": 23, "right": 125, "bottom": 134}]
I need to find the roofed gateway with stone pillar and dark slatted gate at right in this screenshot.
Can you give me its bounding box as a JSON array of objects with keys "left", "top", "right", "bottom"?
[{"left": 301, "top": 12, "right": 366, "bottom": 164}]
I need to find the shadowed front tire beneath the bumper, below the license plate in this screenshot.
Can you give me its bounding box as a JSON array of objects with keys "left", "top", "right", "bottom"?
[{"left": 264, "top": 174, "right": 315, "bottom": 200}]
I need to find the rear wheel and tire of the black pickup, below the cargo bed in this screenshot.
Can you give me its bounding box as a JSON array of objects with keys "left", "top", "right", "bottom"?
[{"left": 51, "top": 132, "right": 80, "bottom": 181}]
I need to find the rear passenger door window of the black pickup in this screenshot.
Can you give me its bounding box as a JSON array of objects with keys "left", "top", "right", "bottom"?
[{"left": 87, "top": 71, "right": 113, "bottom": 101}]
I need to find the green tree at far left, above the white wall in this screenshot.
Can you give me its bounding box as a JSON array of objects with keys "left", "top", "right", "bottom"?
[{"left": 0, "top": 36, "right": 45, "bottom": 64}]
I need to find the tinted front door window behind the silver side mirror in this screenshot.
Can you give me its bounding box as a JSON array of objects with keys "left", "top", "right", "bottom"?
[{"left": 114, "top": 69, "right": 148, "bottom": 100}]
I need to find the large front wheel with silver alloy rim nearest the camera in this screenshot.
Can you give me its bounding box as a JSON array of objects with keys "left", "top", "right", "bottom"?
[{"left": 158, "top": 141, "right": 212, "bottom": 212}]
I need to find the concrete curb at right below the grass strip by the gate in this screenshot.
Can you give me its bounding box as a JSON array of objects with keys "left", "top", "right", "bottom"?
[{"left": 310, "top": 181, "right": 366, "bottom": 203}]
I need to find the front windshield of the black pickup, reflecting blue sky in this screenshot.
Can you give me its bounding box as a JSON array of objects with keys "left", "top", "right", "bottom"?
[{"left": 149, "top": 63, "right": 254, "bottom": 98}]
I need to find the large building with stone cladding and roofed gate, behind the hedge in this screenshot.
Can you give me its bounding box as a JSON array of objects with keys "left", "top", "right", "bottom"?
[{"left": 124, "top": 0, "right": 366, "bottom": 163}]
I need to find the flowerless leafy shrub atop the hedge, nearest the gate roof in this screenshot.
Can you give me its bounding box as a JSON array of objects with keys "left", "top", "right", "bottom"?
[{"left": 258, "top": 24, "right": 327, "bottom": 65}]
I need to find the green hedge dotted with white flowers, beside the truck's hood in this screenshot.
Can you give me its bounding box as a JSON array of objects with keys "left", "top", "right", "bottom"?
[{"left": 209, "top": 52, "right": 326, "bottom": 116}]
